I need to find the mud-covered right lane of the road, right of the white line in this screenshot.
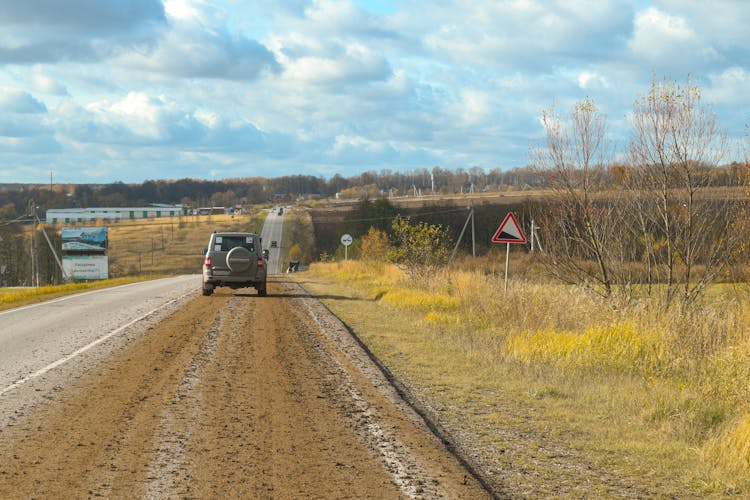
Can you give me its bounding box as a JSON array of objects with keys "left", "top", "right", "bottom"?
[{"left": 0, "top": 276, "right": 490, "bottom": 498}]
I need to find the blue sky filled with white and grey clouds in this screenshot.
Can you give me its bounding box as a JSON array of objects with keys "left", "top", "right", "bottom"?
[{"left": 0, "top": 0, "right": 750, "bottom": 183}]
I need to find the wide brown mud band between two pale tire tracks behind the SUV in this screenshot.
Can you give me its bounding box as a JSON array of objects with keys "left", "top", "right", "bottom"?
[{"left": 185, "top": 296, "right": 408, "bottom": 498}]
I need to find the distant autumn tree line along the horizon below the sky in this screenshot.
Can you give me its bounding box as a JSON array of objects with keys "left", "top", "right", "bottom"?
[{"left": 0, "top": 162, "right": 748, "bottom": 223}]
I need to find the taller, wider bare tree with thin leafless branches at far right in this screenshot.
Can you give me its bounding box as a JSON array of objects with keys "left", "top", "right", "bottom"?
[{"left": 627, "top": 78, "right": 740, "bottom": 305}]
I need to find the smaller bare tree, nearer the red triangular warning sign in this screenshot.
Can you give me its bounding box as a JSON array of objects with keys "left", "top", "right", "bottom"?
[{"left": 533, "top": 99, "right": 621, "bottom": 296}]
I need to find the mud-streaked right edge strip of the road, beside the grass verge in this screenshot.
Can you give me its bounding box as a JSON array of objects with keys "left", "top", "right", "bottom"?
[{"left": 288, "top": 283, "right": 490, "bottom": 498}]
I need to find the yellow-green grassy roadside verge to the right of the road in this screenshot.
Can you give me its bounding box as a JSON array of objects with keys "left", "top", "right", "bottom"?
[{"left": 296, "top": 255, "right": 750, "bottom": 497}]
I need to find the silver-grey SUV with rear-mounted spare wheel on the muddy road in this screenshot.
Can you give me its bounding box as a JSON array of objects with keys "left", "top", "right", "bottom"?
[{"left": 203, "top": 233, "right": 267, "bottom": 296}]
